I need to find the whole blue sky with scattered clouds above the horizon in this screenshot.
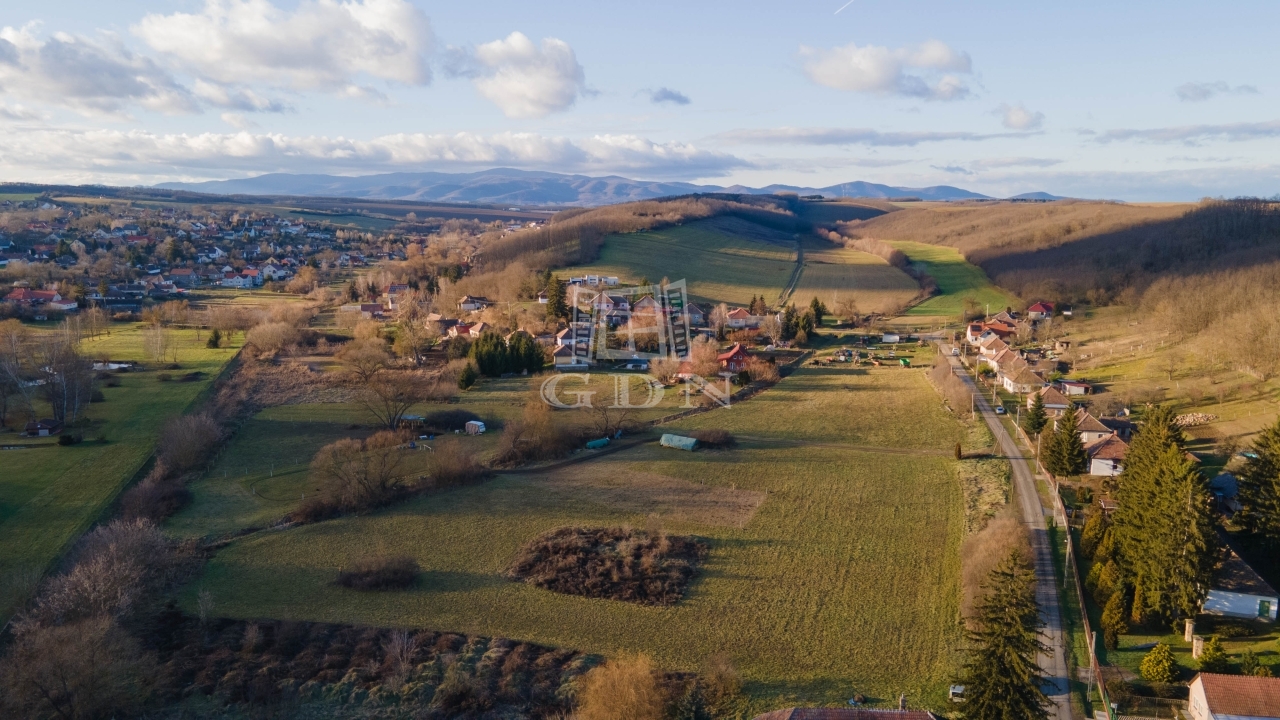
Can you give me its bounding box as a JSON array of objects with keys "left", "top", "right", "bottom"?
[{"left": 0, "top": 0, "right": 1280, "bottom": 201}]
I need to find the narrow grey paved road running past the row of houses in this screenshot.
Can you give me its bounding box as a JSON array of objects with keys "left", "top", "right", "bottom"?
[{"left": 942, "top": 345, "right": 1071, "bottom": 720}]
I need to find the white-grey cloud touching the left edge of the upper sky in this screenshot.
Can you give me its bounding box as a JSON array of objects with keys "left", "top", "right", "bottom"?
[{"left": 0, "top": 26, "right": 197, "bottom": 115}]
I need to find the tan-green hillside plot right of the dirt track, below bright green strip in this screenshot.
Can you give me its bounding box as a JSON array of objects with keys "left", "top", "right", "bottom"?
[{"left": 791, "top": 238, "right": 919, "bottom": 313}]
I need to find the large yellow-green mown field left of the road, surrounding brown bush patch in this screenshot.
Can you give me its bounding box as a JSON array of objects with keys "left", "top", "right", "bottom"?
[{"left": 184, "top": 368, "right": 968, "bottom": 714}]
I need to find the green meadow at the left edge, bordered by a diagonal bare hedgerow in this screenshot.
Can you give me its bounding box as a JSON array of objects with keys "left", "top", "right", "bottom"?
[{"left": 0, "top": 324, "right": 237, "bottom": 618}]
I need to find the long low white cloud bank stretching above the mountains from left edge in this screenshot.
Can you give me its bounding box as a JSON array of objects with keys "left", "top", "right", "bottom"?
[{"left": 0, "top": 124, "right": 749, "bottom": 182}]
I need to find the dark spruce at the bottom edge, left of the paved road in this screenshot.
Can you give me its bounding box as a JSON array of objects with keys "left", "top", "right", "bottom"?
[{"left": 959, "top": 551, "right": 1048, "bottom": 720}]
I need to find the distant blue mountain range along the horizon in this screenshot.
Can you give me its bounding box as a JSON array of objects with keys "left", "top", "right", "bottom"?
[{"left": 156, "top": 168, "right": 1057, "bottom": 205}]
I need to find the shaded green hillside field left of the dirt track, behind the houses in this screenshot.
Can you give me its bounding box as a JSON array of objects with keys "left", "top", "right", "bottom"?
[{"left": 566, "top": 212, "right": 796, "bottom": 305}]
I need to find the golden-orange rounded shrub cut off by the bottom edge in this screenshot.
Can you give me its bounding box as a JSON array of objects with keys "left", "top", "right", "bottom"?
[{"left": 576, "top": 655, "right": 666, "bottom": 720}]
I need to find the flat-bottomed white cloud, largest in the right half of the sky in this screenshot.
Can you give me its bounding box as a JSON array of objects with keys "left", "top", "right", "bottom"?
[{"left": 800, "top": 40, "right": 973, "bottom": 100}]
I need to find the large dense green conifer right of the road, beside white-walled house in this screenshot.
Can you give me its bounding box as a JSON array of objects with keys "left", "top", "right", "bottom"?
[{"left": 1114, "top": 407, "right": 1217, "bottom": 620}]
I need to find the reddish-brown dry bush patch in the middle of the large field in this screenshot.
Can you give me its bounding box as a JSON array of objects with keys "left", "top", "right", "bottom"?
[{"left": 507, "top": 528, "right": 707, "bottom": 606}]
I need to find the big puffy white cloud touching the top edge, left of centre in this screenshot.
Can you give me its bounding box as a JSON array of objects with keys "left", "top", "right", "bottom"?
[{"left": 132, "top": 0, "right": 434, "bottom": 91}]
